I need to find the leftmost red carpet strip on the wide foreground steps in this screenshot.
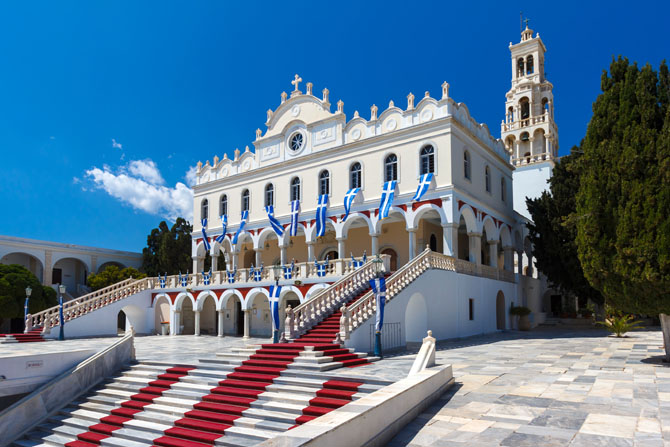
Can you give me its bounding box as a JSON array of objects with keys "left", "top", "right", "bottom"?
[{"left": 65, "top": 366, "right": 195, "bottom": 447}]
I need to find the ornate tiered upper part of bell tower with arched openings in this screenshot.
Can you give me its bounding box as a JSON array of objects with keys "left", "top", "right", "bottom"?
[{"left": 500, "top": 20, "right": 558, "bottom": 167}]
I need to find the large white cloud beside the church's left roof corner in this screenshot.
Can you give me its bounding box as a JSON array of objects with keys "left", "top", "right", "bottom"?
[{"left": 86, "top": 160, "right": 193, "bottom": 221}]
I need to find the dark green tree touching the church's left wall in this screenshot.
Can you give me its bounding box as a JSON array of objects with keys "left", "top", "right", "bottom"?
[{"left": 140, "top": 217, "right": 193, "bottom": 276}]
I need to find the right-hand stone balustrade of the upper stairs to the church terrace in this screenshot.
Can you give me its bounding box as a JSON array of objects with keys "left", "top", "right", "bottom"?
[{"left": 340, "top": 252, "right": 516, "bottom": 339}]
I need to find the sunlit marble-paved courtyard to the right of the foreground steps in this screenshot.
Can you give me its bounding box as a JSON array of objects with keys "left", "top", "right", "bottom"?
[{"left": 388, "top": 329, "right": 670, "bottom": 447}]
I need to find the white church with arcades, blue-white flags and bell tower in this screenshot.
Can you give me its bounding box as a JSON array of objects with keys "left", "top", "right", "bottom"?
[{"left": 30, "top": 29, "right": 558, "bottom": 351}]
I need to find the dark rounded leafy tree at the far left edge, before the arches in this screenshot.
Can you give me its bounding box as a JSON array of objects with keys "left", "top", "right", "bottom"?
[{"left": 0, "top": 264, "right": 58, "bottom": 328}]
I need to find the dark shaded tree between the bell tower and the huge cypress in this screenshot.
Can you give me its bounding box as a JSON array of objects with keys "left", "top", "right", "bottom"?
[{"left": 526, "top": 147, "right": 604, "bottom": 304}]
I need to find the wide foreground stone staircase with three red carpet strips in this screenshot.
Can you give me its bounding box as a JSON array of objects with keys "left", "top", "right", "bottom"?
[{"left": 13, "top": 343, "right": 389, "bottom": 447}]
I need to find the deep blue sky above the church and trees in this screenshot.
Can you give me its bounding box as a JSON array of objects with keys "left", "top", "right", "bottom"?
[{"left": 0, "top": 1, "right": 670, "bottom": 251}]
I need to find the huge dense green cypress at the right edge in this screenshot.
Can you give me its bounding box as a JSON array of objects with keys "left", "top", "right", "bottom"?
[{"left": 576, "top": 57, "right": 670, "bottom": 358}]
